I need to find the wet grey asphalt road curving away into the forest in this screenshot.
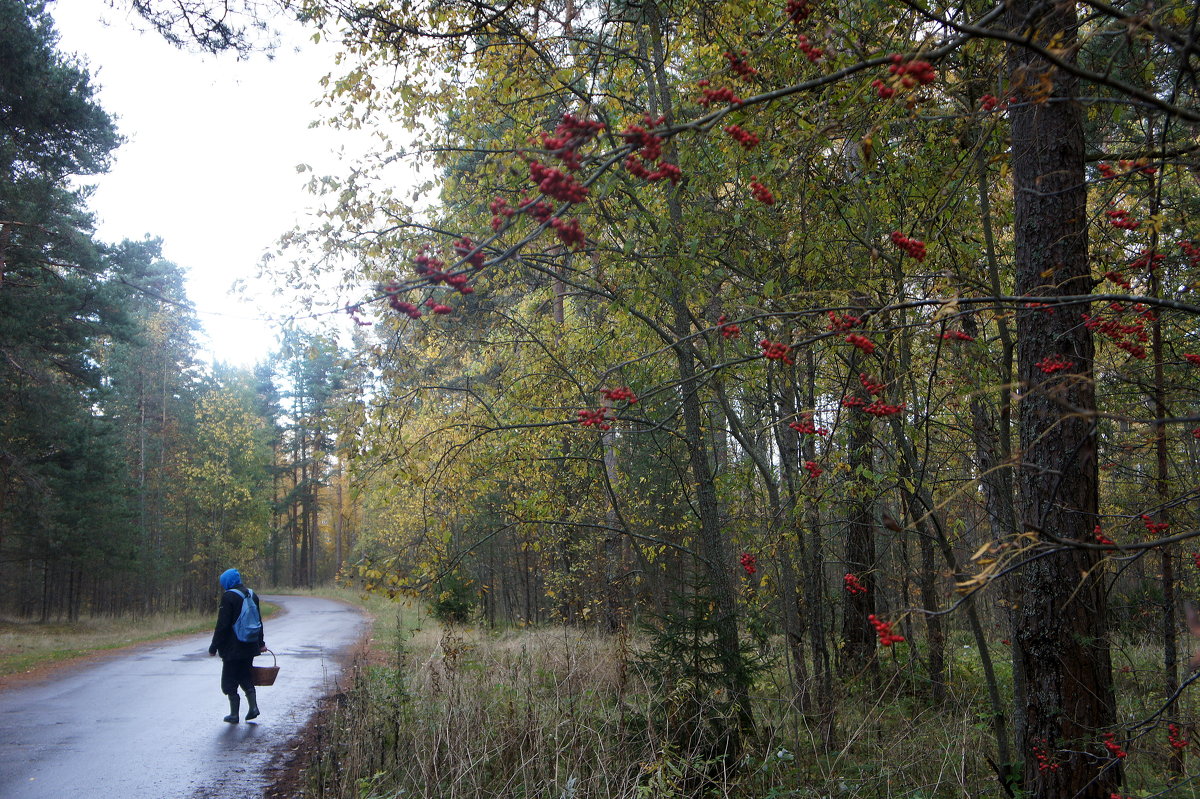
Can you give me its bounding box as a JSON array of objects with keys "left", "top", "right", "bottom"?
[{"left": 0, "top": 595, "right": 365, "bottom": 799}]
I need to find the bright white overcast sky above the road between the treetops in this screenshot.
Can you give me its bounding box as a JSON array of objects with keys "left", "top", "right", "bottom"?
[{"left": 49, "top": 0, "right": 348, "bottom": 366}]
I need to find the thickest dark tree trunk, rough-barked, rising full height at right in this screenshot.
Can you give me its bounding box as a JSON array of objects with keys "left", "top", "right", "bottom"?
[{"left": 1008, "top": 0, "right": 1121, "bottom": 799}]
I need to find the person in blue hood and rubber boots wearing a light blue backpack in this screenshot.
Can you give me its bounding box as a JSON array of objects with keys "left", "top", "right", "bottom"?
[{"left": 209, "top": 569, "right": 266, "bottom": 725}]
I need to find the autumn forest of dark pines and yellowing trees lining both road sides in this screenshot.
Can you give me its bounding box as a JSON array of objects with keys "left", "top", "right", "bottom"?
[{"left": 0, "top": 0, "right": 1200, "bottom": 799}]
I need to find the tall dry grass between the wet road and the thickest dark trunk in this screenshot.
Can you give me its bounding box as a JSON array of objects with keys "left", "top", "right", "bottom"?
[{"left": 297, "top": 625, "right": 1012, "bottom": 799}]
